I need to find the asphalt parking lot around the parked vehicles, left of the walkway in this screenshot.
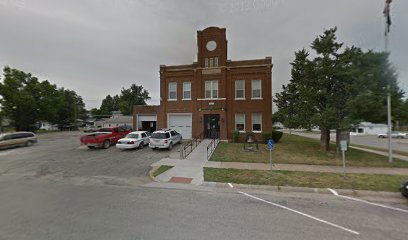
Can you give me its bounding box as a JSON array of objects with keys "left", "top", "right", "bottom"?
[{"left": 0, "top": 131, "right": 178, "bottom": 182}]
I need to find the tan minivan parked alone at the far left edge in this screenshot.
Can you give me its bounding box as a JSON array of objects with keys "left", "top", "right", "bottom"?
[{"left": 0, "top": 132, "right": 37, "bottom": 149}]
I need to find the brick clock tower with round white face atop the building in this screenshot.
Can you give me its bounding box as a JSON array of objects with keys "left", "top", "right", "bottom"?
[{"left": 197, "top": 27, "right": 227, "bottom": 68}]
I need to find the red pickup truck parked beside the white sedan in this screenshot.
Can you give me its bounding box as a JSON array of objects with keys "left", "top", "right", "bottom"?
[{"left": 80, "top": 127, "right": 130, "bottom": 149}]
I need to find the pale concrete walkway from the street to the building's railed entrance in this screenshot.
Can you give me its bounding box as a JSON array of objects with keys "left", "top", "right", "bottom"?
[{"left": 152, "top": 139, "right": 211, "bottom": 185}]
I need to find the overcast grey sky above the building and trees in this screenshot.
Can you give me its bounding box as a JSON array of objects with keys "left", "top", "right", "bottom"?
[{"left": 0, "top": 0, "right": 408, "bottom": 109}]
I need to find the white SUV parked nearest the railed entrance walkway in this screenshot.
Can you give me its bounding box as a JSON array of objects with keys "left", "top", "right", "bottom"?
[{"left": 149, "top": 129, "right": 183, "bottom": 150}]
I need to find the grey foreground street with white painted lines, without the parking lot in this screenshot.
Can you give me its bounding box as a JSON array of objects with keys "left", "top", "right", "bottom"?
[{"left": 0, "top": 176, "right": 408, "bottom": 240}]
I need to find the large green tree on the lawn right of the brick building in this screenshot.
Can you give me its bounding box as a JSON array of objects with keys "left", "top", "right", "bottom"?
[{"left": 275, "top": 28, "right": 403, "bottom": 150}]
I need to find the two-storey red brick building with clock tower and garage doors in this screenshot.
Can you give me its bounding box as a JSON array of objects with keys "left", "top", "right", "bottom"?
[{"left": 133, "top": 27, "right": 272, "bottom": 140}]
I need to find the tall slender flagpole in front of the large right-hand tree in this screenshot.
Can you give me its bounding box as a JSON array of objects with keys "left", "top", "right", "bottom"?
[{"left": 384, "top": 1, "right": 392, "bottom": 163}]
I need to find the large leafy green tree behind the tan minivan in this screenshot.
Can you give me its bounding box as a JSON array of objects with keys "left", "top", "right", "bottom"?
[{"left": 0, "top": 67, "right": 86, "bottom": 130}]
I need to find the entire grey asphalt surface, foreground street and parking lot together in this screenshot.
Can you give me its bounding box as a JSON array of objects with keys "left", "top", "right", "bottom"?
[{"left": 0, "top": 132, "right": 408, "bottom": 240}]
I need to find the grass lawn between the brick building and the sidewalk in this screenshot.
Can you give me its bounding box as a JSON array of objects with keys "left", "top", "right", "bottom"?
[{"left": 210, "top": 134, "right": 408, "bottom": 168}]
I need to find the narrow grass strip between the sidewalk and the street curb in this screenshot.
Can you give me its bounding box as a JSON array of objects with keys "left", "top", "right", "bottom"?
[{"left": 204, "top": 168, "right": 407, "bottom": 192}]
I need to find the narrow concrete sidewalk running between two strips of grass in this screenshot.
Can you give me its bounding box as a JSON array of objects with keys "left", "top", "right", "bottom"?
[{"left": 205, "top": 161, "right": 408, "bottom": 176}]
